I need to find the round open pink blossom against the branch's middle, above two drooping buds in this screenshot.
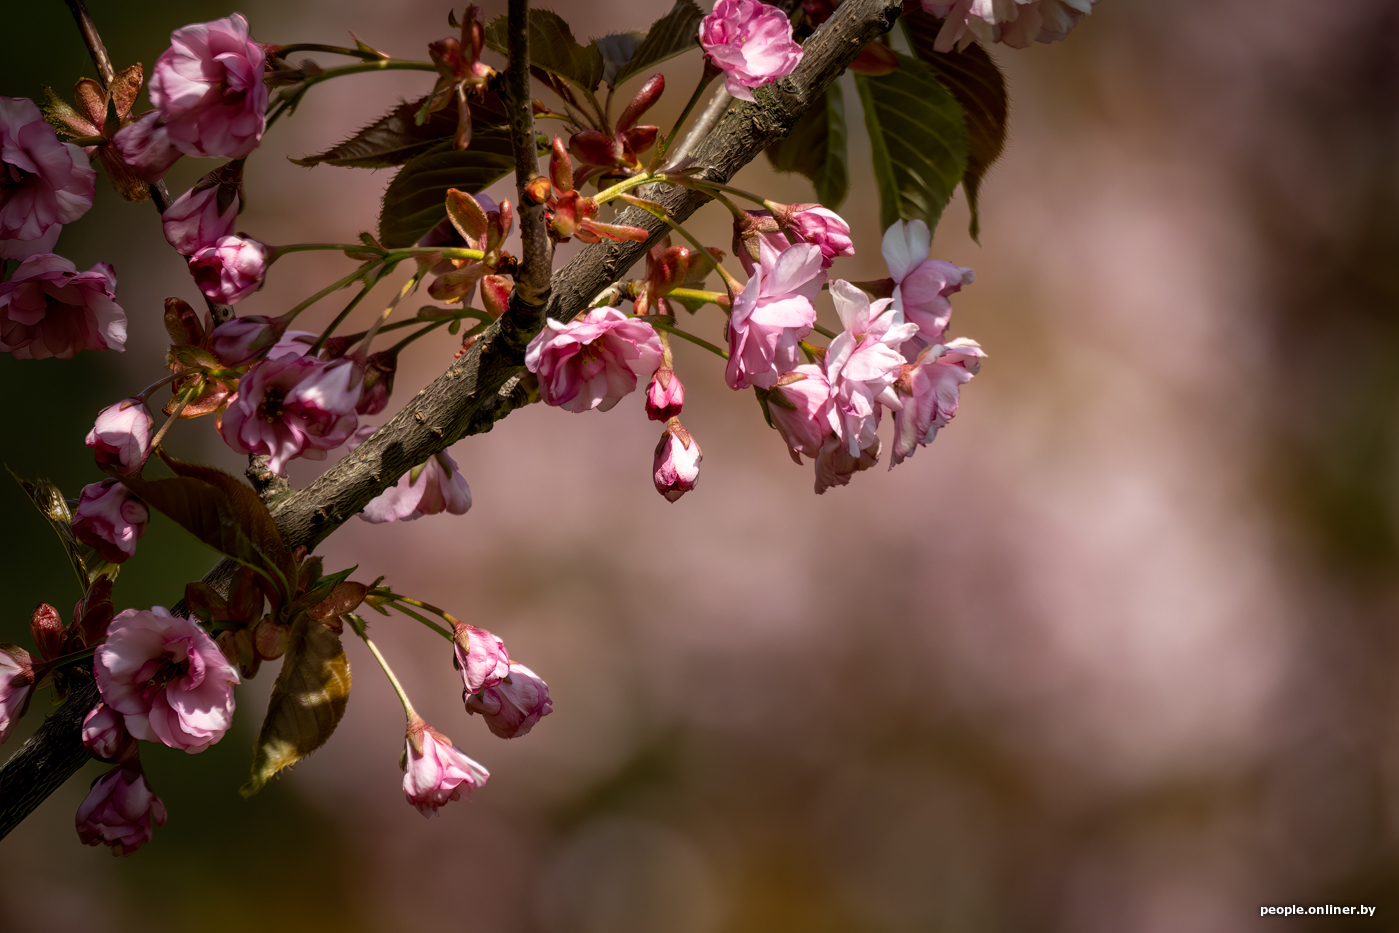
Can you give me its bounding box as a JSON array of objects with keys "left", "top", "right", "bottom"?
[{"left": 525, "top": 308, "right": 662, "bottom": 411}]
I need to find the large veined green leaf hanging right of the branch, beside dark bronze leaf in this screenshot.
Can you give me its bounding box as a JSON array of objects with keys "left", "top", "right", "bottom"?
[{"left": 855, "top": 53, "right": 967, "bottom": 229}]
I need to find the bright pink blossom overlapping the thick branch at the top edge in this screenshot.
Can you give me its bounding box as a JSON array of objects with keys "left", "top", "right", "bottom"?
[{"left": 700, "top": 0, "right": 802, "bottom": 101}]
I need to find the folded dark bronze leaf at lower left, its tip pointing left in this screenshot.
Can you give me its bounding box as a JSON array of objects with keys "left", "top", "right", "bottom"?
[{"left": 118, "top": 455, "right": 297, "bottom": 600}]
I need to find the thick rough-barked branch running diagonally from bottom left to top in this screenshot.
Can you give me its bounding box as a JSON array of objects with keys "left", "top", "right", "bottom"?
[{"left": 0, "top": 0, "right": 902, "bottom": 835}]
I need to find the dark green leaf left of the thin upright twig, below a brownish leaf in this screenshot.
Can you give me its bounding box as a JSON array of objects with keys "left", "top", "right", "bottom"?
[{"left": 379, "top": 127, "right": 515, "bottom": 249}]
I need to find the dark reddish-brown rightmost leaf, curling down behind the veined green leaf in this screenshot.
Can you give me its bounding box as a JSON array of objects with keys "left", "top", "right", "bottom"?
[{"left": 902, "top": 7, "right": 1009, "bottom": 239}]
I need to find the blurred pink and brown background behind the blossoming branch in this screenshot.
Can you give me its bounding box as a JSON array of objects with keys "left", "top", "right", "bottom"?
[{"left": 0, "top": 0, "right": 1399, "bottom": 933}]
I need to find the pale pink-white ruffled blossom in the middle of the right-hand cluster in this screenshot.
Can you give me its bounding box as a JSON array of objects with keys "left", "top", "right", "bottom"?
[{"left": 825, "top": 278, "right": 918, "bottom": 457}]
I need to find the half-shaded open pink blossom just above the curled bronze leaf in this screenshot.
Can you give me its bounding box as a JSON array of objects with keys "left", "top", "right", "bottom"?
[{"left": 218, "top": 354, "right": 364, "bottom": 473}]
